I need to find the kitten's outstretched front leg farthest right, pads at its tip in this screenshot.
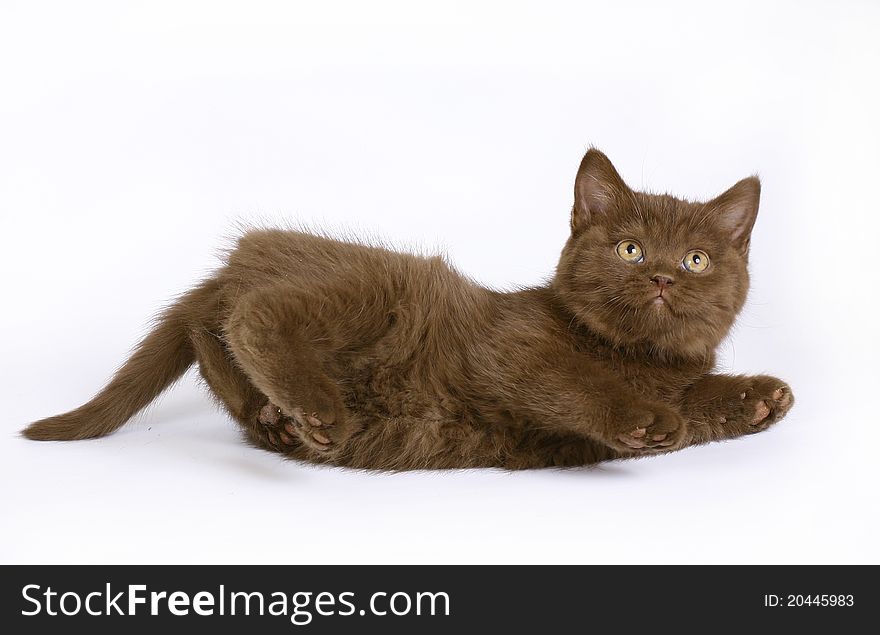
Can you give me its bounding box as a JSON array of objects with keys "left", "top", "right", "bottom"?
[{"left": 680, "top": 375, "right": 794, "bottom": 445}]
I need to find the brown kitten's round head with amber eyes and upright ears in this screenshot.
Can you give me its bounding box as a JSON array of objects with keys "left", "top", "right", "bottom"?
[{"left": 553, "top": 149, "right": 761, "bottom": 357}]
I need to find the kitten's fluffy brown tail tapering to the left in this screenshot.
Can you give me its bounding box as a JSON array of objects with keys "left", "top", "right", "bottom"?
[{"left": 22, "top": 282, "right": 213, "bottom": 441}]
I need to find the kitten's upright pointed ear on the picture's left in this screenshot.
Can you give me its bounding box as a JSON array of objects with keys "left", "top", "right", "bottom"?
[{"left": 571, "top": 148, "right": 629, "bottom": 234}]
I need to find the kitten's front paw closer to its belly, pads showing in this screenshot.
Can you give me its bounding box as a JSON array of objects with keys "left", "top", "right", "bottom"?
[{"left": 606, "top": 403, "right": 686, "bottom": 455}]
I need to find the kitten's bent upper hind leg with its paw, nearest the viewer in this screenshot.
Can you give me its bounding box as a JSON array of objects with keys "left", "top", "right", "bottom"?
[{"left": 225, "top": 285, "right": 384, "bottom": 458}]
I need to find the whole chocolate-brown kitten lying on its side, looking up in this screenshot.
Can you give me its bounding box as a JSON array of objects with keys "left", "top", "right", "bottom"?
[{"left": 23, "top": 148, "right": 794, "bottom": 470}]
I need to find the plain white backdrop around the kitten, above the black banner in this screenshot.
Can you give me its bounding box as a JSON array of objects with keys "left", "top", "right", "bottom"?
[{"left": 0, "top": 0, "right": 880, "bottom": 563}]
